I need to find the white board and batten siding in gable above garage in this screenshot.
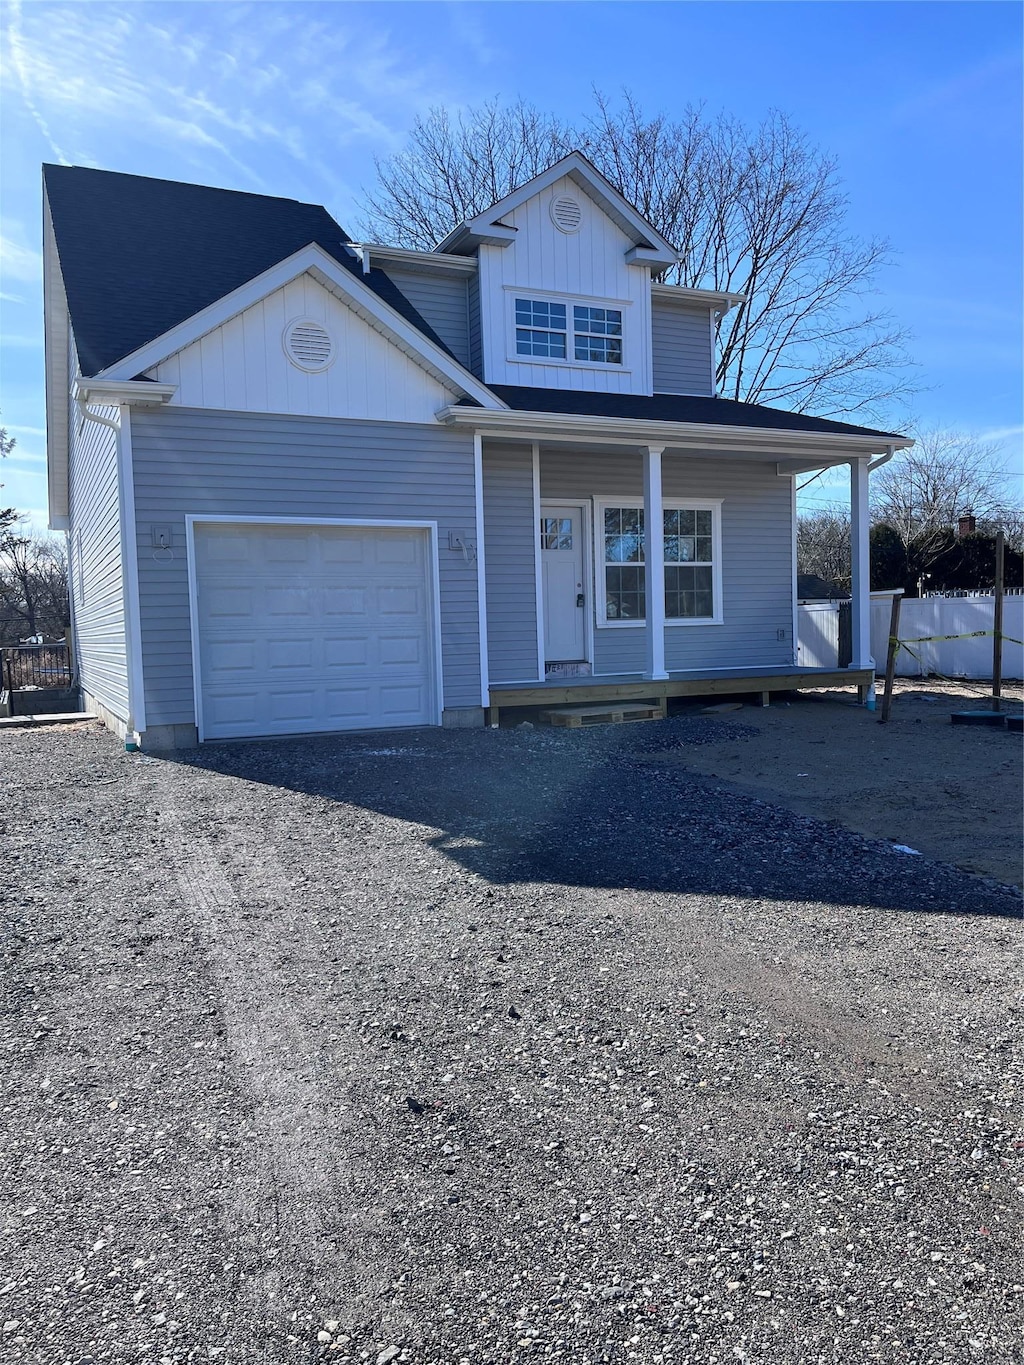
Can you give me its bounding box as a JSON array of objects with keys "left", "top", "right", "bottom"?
[{"left": 147, "top": 274, "right": 456, "bottom": 422}]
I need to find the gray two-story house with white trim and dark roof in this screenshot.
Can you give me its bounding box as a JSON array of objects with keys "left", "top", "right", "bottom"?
[{"left": 44, "top": 153, "right": 909, "bottom": 748}]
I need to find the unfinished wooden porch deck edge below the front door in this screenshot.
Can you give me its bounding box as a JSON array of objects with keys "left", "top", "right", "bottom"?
[{"left": 487, "top": 667, "right": 874, "bottom": 725}]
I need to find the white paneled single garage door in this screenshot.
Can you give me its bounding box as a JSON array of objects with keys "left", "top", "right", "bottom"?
[{"left": 195, "top": 523, "right": 437, "bottom": 740}]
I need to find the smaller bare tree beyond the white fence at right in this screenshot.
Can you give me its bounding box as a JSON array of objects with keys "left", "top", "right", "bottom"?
[{"left": 871, "top": 429, "right": 1020, "bottom": 575}]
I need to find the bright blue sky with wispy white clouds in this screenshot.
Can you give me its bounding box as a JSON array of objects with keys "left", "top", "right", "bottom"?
[{"left": 0, "top": 0, "right": 1023, "bottom": 527}]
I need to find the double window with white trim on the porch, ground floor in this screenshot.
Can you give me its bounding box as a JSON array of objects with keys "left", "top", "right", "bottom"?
[{"left": 595, "top": 501, "right": 721, "bottom": 625}]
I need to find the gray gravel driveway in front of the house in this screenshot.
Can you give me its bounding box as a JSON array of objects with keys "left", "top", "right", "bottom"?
[{"left": 0, "top": 719, "right": 1024, "bottom": 1365}]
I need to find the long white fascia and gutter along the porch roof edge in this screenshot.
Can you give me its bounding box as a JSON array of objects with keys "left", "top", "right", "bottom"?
[{"left": 437, "top": 405, "right": 913, "bottom": 470}]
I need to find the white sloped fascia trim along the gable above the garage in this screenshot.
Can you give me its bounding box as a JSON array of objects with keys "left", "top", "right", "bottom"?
[{"left": 97, "top": 243, "right": 505, "bottom": 408}]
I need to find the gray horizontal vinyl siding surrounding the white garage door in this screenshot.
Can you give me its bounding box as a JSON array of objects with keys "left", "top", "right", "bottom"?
[{"left": 132, "top": 407, "right": 481, "bottom": 725}]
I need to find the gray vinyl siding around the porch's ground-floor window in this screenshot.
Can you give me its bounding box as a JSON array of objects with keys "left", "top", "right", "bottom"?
[{"left": 541, "top": 450, "right": 793, "bottom": 674}]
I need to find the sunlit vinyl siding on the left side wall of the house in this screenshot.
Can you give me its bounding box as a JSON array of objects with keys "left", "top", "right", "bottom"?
[{"left": 68, "top": 395, "right": 130, "bottom": 721}]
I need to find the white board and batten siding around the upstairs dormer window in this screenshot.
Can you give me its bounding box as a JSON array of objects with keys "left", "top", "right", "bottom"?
[{"left": 479, "top": 176, "right": 653, "bottom": 393}]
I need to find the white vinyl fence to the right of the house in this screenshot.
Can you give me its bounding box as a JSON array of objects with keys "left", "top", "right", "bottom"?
[{"left": 796, "top": 592, "right": 1024, "bottom": 678}]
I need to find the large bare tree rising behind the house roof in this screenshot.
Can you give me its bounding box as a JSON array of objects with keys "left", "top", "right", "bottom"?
[{"left": 363, "top": 93, "right": 912, "bottom": 416}]
